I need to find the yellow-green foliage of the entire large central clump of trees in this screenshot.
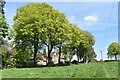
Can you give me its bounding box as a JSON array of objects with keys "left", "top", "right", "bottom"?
[{"left": 13, "top": 3, "right": 95, "bottom": 63}]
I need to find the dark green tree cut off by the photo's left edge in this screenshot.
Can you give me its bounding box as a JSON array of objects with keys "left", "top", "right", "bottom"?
[{"left": 0, "top": 0, "right": 10, "bottom": 67}]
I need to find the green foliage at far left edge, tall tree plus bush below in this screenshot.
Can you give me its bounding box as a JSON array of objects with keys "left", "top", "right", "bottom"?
[{"left": 0, "top": 0, "right": 14, "bottom": 67}]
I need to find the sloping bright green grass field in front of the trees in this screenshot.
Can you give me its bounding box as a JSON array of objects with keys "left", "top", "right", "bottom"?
[{"left": 2, "top": 62, "right": 118, "bottom": 78}]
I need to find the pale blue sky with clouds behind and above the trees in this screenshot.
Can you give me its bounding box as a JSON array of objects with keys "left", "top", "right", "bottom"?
[{"left": 4, "top": 2, "right": 118, "bottom": 60}]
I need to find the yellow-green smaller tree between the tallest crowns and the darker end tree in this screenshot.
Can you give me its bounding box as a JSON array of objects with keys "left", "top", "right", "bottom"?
[{"left": 62, "top": 24, "right": 85, "bottom": 62}]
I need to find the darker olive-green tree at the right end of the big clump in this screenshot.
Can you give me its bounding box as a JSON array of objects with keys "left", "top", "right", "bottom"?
[{"left": 77, "top": 31, "right": 96, "bottom": 62}]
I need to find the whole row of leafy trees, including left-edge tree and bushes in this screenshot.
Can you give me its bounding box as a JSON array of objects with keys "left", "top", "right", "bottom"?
[{"left": 0, "top": 1, "right": 119, "bottom": 66}]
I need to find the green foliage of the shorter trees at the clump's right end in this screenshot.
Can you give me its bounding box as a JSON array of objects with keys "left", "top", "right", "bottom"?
[{"left": 62, "top": 24, "right": 96, "bottom": 62}]
